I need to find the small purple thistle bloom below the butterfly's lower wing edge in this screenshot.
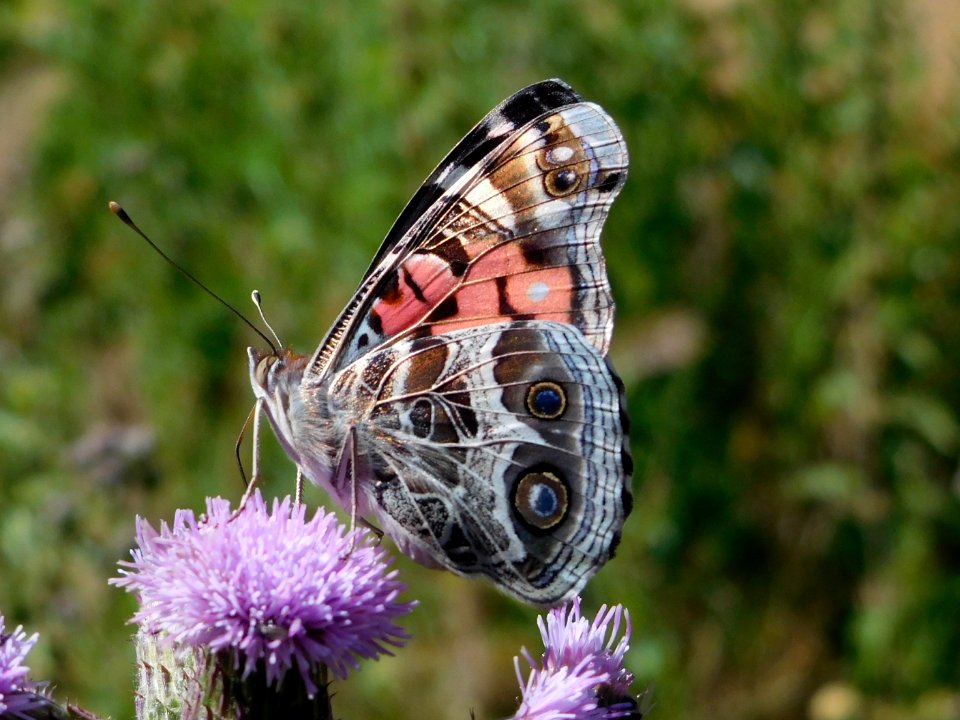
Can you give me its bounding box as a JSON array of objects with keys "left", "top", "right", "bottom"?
[{"left": 514, "top": 598, "right": 642, "bottom": 720}]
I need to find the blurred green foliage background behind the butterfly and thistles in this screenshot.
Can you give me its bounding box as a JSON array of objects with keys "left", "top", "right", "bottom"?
[{"left": 0, "top": 0, "right": 960, "bottom": 720}]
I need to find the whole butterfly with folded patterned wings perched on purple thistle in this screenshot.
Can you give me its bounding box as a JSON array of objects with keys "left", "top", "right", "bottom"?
[{"left": 248, "top": 80, "right": 633, "bottom": 606}]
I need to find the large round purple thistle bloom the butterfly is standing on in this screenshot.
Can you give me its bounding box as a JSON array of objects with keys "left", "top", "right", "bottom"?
[{"left": 111, "top": 492, "right": 415, "bottom": 697}]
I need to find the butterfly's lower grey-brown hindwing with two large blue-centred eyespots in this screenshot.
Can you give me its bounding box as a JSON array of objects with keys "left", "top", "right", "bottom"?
[{"left": 332, "top": 321, "right": 632, "bottom": 605}]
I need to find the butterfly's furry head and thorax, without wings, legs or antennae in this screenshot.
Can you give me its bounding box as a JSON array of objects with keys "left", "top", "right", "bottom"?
[{"left": 247, "top": 348, "right": 348, "bottom": 503}]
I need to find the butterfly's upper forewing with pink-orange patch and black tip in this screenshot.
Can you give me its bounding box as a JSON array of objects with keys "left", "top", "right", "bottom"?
[{"left": 310, "top": 81, "right": 627, "bottom": 377}]
